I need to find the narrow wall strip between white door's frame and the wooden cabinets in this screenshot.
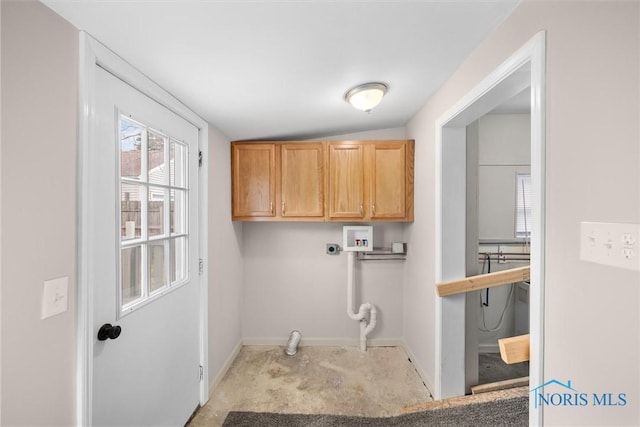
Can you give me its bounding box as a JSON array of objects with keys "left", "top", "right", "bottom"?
[{"left": 207, "top": 126, "right": 243, "bottom": 385}]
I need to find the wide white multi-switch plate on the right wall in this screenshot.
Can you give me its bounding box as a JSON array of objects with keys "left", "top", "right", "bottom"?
[{"left": 580, "top": 222, "right": 640, "bottom": 270}]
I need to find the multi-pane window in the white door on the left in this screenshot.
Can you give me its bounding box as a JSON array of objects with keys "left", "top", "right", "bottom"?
[{"left": 118, "top": 115, "right": 189, "bottom": 315}]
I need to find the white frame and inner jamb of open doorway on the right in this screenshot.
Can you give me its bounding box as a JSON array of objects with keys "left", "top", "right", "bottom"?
[{"left": 434, "top": 31, "right": 546, "bottom": 425}]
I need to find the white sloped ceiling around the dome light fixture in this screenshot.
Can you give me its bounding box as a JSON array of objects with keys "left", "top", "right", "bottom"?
[{"left": 41, "top": 0, "right": 520, "bottom": 140}]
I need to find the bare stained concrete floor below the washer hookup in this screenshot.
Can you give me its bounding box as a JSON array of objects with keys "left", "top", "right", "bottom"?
[{"left": 189, "top": 346, "right": 432, "bottom": 427}]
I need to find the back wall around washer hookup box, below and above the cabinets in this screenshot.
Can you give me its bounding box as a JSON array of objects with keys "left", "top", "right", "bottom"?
[{"left": 243, "top": 128, "right": 411, "bottom": 345}]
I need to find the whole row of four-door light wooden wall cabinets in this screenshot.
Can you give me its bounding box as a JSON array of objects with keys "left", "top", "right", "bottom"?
[{"left": 231, "top": 140, "right": 414, "bottom": 222}]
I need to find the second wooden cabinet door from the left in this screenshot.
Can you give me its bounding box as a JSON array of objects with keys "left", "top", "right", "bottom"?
[{"left": 280, "top": 143, "right": 324, "bottom": 219}]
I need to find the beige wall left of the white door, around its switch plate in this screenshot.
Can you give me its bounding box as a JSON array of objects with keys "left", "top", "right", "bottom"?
[{"left": 0, "top": 1, "right": 78, "bottom": 426}]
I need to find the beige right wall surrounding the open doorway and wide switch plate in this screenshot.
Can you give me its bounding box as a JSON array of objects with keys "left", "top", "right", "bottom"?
[{"left": 404, "top": 1, "right": 640, "bottom": 425}]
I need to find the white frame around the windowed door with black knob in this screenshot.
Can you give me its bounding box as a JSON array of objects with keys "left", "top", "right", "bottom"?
[{"left": 76, "top": 31, "right": 209, "bottom": 425}]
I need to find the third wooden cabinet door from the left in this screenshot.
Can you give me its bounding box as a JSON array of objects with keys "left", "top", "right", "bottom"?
[{"left": 329, "top": 143, "right": 365, "bottom": 219}]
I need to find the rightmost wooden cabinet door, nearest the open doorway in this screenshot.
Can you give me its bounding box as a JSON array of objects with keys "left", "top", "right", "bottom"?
[{"left": 368, "top": 141, "right": 407, "bottom": 219}]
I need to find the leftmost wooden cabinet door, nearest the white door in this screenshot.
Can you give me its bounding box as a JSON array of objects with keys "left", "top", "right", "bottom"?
[{"left": 231, "top": 144, "right": 276, "bottom": 219}]
